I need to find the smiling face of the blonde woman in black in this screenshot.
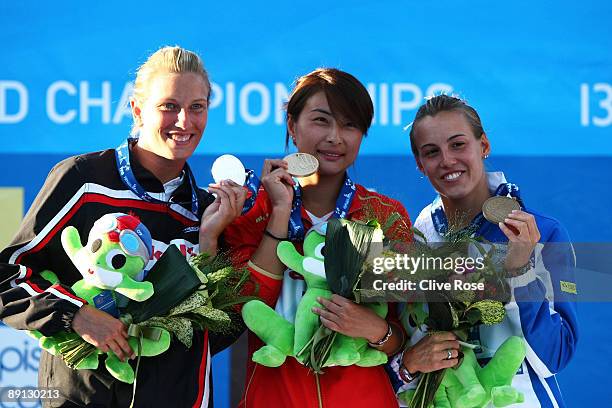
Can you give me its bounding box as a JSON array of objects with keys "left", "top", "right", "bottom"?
[{"left": 131, "top": 72, "right": 209, "bottom": 161}]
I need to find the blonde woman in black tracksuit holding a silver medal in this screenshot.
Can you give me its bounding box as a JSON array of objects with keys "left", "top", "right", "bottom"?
[{"left": 0, "top": 47, "right": 251, "bottom": 407}]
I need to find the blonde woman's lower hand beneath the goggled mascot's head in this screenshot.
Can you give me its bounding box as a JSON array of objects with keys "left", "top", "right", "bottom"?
[{"left": 72, "top": 305, "right": 136, "bottom": 361}]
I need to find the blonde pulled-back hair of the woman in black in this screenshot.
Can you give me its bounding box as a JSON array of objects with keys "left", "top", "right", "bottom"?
[{"left": 131, "top": 46, "right": 211, "bottom": 135}]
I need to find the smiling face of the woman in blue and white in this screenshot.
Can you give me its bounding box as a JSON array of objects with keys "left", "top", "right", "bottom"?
[{"left": 414, "top": 110, "right": 490, "bottom": 200}]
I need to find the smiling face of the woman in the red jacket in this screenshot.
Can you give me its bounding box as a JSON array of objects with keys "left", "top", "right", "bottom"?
[{"left": 287, "top": 91, "right": 363, "bottom": 176}]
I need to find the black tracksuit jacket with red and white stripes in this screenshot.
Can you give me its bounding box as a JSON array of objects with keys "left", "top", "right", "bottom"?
[{"left": 0, "top": 149, "right": 235, "bottom": 407}]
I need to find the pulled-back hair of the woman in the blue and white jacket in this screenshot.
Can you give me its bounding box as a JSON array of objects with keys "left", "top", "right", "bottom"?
[{"left": 410, "top": 95, "right": 484, "bottom": 157}]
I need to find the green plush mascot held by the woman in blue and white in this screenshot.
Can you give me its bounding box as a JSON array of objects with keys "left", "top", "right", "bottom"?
[{"left": 399, "top": 336, "right": 525, "bottom": 408}]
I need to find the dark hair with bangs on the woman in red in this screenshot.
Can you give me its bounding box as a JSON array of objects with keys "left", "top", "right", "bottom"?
[{"left": 285, "top": 68, "right": 374, "bottom": 146}]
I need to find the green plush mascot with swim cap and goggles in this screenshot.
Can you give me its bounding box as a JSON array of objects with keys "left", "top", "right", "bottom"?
[{"left": 30, "top": 213, "right": 170, "bottom": 384}]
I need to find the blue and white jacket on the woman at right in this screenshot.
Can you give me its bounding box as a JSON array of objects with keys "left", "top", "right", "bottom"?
[{"left": 387, "top": 172, "right": 578, "bottom": 408}]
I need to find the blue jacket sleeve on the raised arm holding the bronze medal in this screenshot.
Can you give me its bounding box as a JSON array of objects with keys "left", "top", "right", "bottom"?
[{"left": 511, "top": 224, "right": 578, "bottom": 378}]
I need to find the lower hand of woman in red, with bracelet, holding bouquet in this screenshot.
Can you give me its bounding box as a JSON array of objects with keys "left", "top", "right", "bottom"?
[{"left": 312, "top": 294, "right": 388, "bottom": 343}]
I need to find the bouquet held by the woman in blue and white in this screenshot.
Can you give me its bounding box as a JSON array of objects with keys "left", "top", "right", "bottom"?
[{"left": 386, "top": 229, "right": 510, "bottom": 408}]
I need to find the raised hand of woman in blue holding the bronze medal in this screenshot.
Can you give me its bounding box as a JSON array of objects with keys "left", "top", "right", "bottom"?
[{"left": 499, "top": 210, "right": 540, "bottom": 270}]
